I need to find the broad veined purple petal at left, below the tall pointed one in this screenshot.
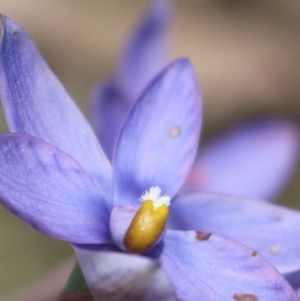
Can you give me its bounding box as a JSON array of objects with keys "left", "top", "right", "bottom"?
[{"left": 0, "top": 134, "right": 110, "bottom": 244}]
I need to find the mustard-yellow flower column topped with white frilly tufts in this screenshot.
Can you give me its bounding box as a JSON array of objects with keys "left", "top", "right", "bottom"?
[{"left": 124, "top": 186, "right": 170, "bottom": 254}]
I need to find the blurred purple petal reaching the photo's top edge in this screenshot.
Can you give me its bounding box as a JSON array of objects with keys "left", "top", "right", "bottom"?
[{"left": 116, "top": 0, "right": 171, "bottom": 102}]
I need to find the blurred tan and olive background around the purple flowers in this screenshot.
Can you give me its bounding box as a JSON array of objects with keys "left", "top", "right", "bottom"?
[{"left": 0, "top": 0, "right": 300, "bottom": 301}]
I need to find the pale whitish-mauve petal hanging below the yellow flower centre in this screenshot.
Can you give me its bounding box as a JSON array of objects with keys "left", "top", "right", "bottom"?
[{"left": 75, "top": 247, "right": 177, "bottom": 301}]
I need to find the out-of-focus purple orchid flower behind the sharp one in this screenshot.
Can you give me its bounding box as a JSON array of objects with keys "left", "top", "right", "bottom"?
[{"left": 90, "top": 0, "right": 300, "bottom": 201}]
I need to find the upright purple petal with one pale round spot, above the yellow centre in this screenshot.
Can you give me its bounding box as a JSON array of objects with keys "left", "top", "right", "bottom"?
[{"left": 113, "top": 59, "right": 201, "bottom": 206}]
